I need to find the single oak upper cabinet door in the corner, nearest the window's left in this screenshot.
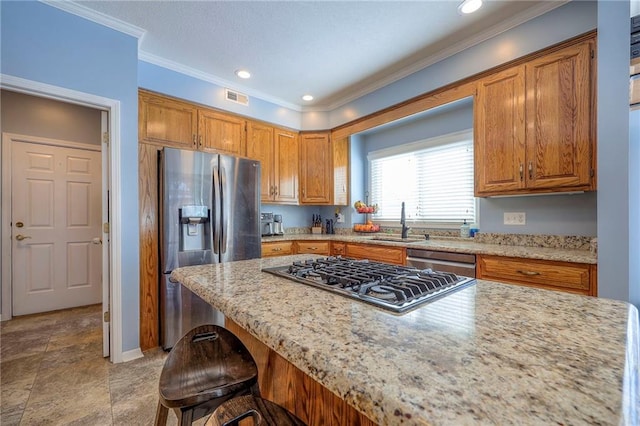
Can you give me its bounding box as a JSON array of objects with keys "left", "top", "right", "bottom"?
[{"left": 300, "top": 133, "right": 333, "bottom": 204}]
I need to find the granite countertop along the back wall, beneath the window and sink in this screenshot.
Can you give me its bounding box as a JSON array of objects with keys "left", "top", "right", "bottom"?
[{"left": 262, "top": 234, "right": 598, "bottom": 265}]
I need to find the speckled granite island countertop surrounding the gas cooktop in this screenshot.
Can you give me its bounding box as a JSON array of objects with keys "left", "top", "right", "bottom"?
[{"left": 172, "top": 255, "right": 640, "bottom": 425}]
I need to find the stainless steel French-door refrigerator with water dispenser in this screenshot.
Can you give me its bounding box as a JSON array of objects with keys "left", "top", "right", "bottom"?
[{"left": 158, "top": 148, "right": 261, "bottom": 350}]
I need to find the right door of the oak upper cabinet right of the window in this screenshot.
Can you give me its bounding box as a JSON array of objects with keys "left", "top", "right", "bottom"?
[{"left": 526, "top": 41, "right": 593, "bottom": 189}]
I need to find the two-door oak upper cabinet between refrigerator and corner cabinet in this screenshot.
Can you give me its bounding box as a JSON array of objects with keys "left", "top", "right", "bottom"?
[{"left": 247, "top": 121, "right": 298, "bottom": 204}]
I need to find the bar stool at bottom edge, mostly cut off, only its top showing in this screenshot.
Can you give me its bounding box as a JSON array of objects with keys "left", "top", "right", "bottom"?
[{"left": 205, "top": 395, "right": 305, "bottom": 426}]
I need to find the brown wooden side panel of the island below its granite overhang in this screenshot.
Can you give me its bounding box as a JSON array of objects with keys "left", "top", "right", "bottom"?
[{"left": 225, "top": 318, "right": 376, "bottom": 426}]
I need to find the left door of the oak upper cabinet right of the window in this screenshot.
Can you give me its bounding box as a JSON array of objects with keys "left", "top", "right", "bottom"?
[{"left": 474, "top": 66, "right": 525, "bottom": 196}]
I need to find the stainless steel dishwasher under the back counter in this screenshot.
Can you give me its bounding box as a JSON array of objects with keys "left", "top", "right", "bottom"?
[{"left": 407, "top": 248, "right": 476, "bottom": 278}]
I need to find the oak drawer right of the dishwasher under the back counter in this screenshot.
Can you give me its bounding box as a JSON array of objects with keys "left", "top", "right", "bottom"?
[{"left": 478, "top": 256, "right": 591, "bottom": 294}]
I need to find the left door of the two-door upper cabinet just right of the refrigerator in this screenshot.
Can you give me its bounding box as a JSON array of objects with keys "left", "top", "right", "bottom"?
[{"left": 247, "top": 121, "right": 275, "bottom": 202}]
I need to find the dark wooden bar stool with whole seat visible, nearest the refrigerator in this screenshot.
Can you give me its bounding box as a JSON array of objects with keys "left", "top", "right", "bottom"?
[{"left": 155, "top": 325, "right": 260, "bottom": 426}]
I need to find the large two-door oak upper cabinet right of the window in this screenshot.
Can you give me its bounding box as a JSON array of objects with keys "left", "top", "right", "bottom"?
[{"left": 474, "top": 39, "right": 595, "bottom": 197}]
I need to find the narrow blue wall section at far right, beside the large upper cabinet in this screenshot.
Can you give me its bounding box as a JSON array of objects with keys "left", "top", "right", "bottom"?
[{"left": 597, "top": 1, "right": 640, "bottom": 305}]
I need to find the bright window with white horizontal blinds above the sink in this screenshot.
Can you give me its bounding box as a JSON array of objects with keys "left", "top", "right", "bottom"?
[{"left": 368, "top": 131, "right": 476, "bottom": 226}]
